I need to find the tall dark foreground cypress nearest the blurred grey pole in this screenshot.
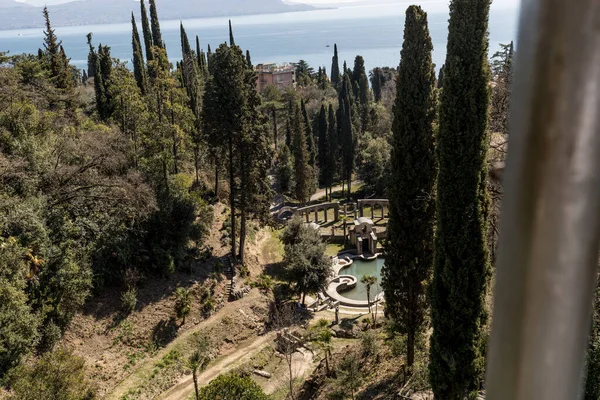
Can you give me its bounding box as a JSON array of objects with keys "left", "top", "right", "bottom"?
[{"left": 429, "top": 0, "right": 490, "bottom": 400}]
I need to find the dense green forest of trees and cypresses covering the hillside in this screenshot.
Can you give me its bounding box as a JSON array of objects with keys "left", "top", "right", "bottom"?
[{"left": 0, "top": 0, "right": 600, "bottom": 400}]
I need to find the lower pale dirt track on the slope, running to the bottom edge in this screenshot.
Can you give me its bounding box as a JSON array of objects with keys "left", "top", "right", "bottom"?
[{"left": 159, "top": 332, "right": 275, "bottom": 400}]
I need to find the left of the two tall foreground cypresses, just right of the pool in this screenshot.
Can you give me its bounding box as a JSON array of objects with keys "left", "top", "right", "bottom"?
[{"left": 382, "top": 6, "right": 437, "bottom": 367}]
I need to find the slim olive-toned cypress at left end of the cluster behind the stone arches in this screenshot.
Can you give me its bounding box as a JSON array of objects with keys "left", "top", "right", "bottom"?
[{"left": 291, "top": 103, "right": 313, "bottom": 204}]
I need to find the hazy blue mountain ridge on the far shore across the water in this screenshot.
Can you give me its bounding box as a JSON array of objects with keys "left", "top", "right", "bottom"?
[{"left": 0, "top": 0, "right": 313, "bottom": 30}]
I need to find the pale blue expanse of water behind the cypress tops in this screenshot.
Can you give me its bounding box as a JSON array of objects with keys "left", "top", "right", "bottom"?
[{"left": 0, "top": 0, "right": 517, "bottom": 71}]
